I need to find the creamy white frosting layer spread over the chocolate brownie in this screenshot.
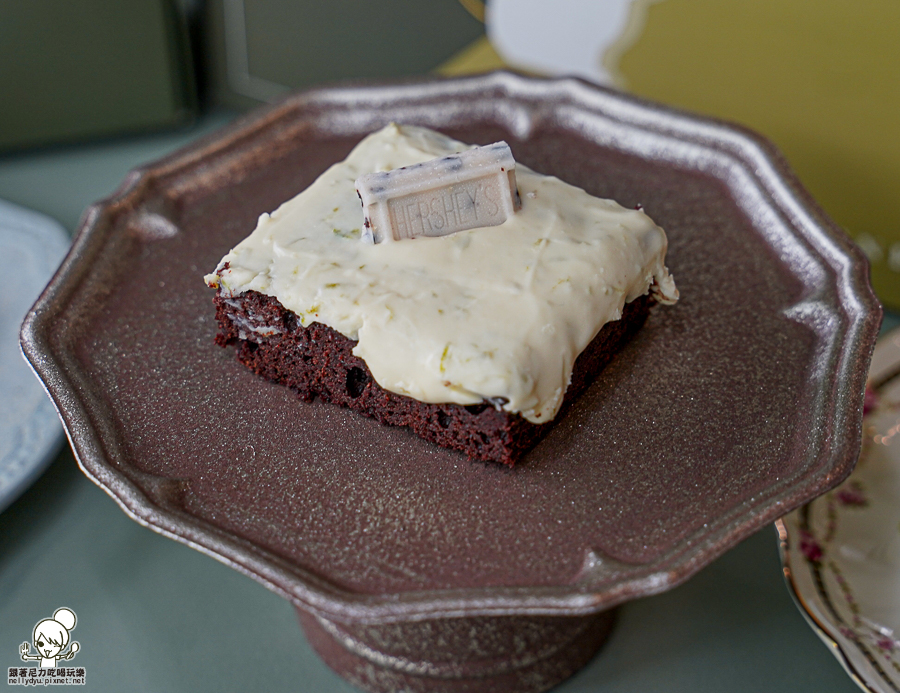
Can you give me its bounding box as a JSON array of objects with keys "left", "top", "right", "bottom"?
[{"left": 205, "top": 125, "right": 678, "bottom": 423}]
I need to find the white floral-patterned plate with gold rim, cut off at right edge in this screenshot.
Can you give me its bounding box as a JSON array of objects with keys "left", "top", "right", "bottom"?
[{"left": 777, "top": 328, "right": 900, "bottom": 692}]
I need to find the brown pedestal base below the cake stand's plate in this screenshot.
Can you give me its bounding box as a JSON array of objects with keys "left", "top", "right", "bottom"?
[{"left": 297, "top": 608, "right": 614, "bottom": 693}]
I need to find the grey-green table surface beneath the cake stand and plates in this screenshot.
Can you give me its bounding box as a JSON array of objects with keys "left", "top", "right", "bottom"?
[{"left": 0, "top": 113, "right": 884, "bottom": 693}]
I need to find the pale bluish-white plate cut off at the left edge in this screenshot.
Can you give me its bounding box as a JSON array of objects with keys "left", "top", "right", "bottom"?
[{"left": 0, "top": 200, "right": 69, "bottom": 511}]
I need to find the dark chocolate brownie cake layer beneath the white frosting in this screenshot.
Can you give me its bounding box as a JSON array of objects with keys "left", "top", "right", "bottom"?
[{"left": 214, "top": 291, "right": 654, "bottom": 466}]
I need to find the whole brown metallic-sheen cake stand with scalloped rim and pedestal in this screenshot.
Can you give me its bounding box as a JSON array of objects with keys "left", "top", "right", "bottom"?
[{"left": 22, "top": 73, "right": 880, "bottom": 691}]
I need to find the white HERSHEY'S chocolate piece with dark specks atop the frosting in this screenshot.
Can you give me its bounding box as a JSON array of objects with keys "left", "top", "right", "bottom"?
[{"left": 356, "top": 142, "right": 522, "bottom": 243}]
